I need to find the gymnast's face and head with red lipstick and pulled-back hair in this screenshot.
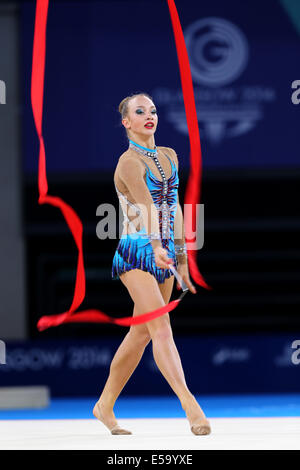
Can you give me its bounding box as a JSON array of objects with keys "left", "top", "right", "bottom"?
[{"left": 122, "top": 95, "right": 158, "bottom": 138}]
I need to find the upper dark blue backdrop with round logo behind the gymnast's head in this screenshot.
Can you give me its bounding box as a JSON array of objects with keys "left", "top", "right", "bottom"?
[{"left": 21, "top": 0, "right": 300, "bottom": 174}]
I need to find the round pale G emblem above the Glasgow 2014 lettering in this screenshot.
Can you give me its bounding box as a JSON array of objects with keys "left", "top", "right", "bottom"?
[{"left": 184, "top": 17, "right": 249, "bottom": 87}]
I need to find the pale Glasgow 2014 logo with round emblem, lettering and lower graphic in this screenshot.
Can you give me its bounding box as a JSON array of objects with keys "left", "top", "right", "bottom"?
[{"left": 152, "top": 17, "right": 275, "bottom": 145}]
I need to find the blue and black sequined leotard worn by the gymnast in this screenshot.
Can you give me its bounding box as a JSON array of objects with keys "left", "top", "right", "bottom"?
[{"left": 112, "top": 142, "right": 179, "bottom": 283}]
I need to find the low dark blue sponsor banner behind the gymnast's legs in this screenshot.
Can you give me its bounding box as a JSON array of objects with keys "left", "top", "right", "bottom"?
[{"left": 0, "top": 332, "right": 300, "bottom": 397}]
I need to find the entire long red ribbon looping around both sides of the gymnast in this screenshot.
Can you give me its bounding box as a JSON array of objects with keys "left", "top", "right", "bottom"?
[{"left": 31, "top": 0, "right": 208, "bottom": 331}]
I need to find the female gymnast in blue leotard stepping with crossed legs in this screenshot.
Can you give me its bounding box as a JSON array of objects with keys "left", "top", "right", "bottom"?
[{"left": 93, "top": 92, "right": 211, "bottom": 435}]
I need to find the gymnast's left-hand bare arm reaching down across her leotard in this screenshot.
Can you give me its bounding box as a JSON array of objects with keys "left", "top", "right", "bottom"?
[{"left": 118, "top": 157, "right": 173, "bottom": 269}]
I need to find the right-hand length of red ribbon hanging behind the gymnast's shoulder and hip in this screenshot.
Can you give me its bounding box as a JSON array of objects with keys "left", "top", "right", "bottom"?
[{"left": 167, "top": 0, "right": 211, "bottom": 289}]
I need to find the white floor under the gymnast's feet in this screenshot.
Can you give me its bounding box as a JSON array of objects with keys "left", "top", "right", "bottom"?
[{"left": 0, "top": 417, "right": 300, "bottom": 450}]
